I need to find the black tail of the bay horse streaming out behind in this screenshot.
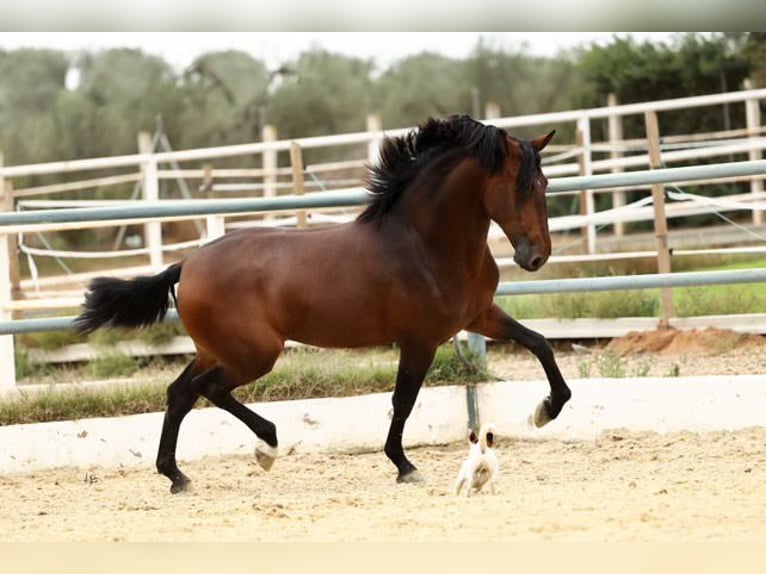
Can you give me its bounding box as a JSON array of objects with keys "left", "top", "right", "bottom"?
[{"left": 75, "top": 263, "right": 182, "bottom": 333}]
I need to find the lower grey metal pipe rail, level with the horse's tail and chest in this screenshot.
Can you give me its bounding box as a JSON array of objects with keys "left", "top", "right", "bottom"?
[{"left": 0, "top": 269, "right": 766, "bottom": 335}]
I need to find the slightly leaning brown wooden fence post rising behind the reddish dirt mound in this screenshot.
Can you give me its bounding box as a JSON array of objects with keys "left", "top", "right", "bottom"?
[{"left": 644, "top": 111, "right": 674, "bottom": 328}]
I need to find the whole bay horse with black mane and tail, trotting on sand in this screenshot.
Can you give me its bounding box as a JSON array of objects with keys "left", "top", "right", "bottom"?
[{"left": 76, "top": 116, "right": 571, "bottom": 493}]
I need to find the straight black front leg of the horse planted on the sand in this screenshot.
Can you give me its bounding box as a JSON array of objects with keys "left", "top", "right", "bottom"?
[{"left": 385, "top": 344, "right": 436, "bottom": 482}]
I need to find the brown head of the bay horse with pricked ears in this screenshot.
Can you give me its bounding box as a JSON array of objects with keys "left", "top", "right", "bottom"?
[{"left": 484, "top": 130, "right": 555, "bottom": 271}]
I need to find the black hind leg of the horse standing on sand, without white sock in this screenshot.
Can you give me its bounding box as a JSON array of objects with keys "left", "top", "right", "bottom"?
[{"left": 157, "top": 359, "right": 199, "bottom": 494}]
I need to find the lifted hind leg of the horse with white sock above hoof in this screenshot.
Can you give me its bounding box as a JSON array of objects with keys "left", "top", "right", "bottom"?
[{"left": 192, "top": 361, "right": 277, "bottom": 470}]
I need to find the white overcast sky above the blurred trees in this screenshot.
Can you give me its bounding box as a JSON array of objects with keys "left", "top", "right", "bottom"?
[{"left": 0, "top": 32, "right": 673, "bottom": 69}]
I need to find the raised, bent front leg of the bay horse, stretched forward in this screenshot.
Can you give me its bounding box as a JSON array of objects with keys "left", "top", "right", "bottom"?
[{"left": 467, "top": 305, "right": 572, "bottom": 427}]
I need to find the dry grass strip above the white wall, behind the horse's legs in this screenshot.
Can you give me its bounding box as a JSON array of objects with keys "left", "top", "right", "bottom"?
[{"left": 0, "top": 344, "right": 488, "bottom": 425}]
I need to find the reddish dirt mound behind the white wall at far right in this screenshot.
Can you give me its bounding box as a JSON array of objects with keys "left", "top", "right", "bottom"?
[{"left": 606, "top": 327, "right": 766, "bottom": 356}]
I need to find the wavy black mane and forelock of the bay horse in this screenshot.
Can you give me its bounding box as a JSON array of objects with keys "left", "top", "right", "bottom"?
[{"left": 358, "top": 115, "right": 539, "bottom": 222}]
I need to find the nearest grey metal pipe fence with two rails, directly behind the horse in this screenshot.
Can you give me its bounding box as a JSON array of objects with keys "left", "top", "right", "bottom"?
[{"left": 0, "top": 160, "right": 766, "bottom": 389}]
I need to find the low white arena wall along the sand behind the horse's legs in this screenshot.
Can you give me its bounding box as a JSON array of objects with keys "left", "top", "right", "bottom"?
[{"left": 0, "top": 375, "right": 766, "bottom": 474}]
